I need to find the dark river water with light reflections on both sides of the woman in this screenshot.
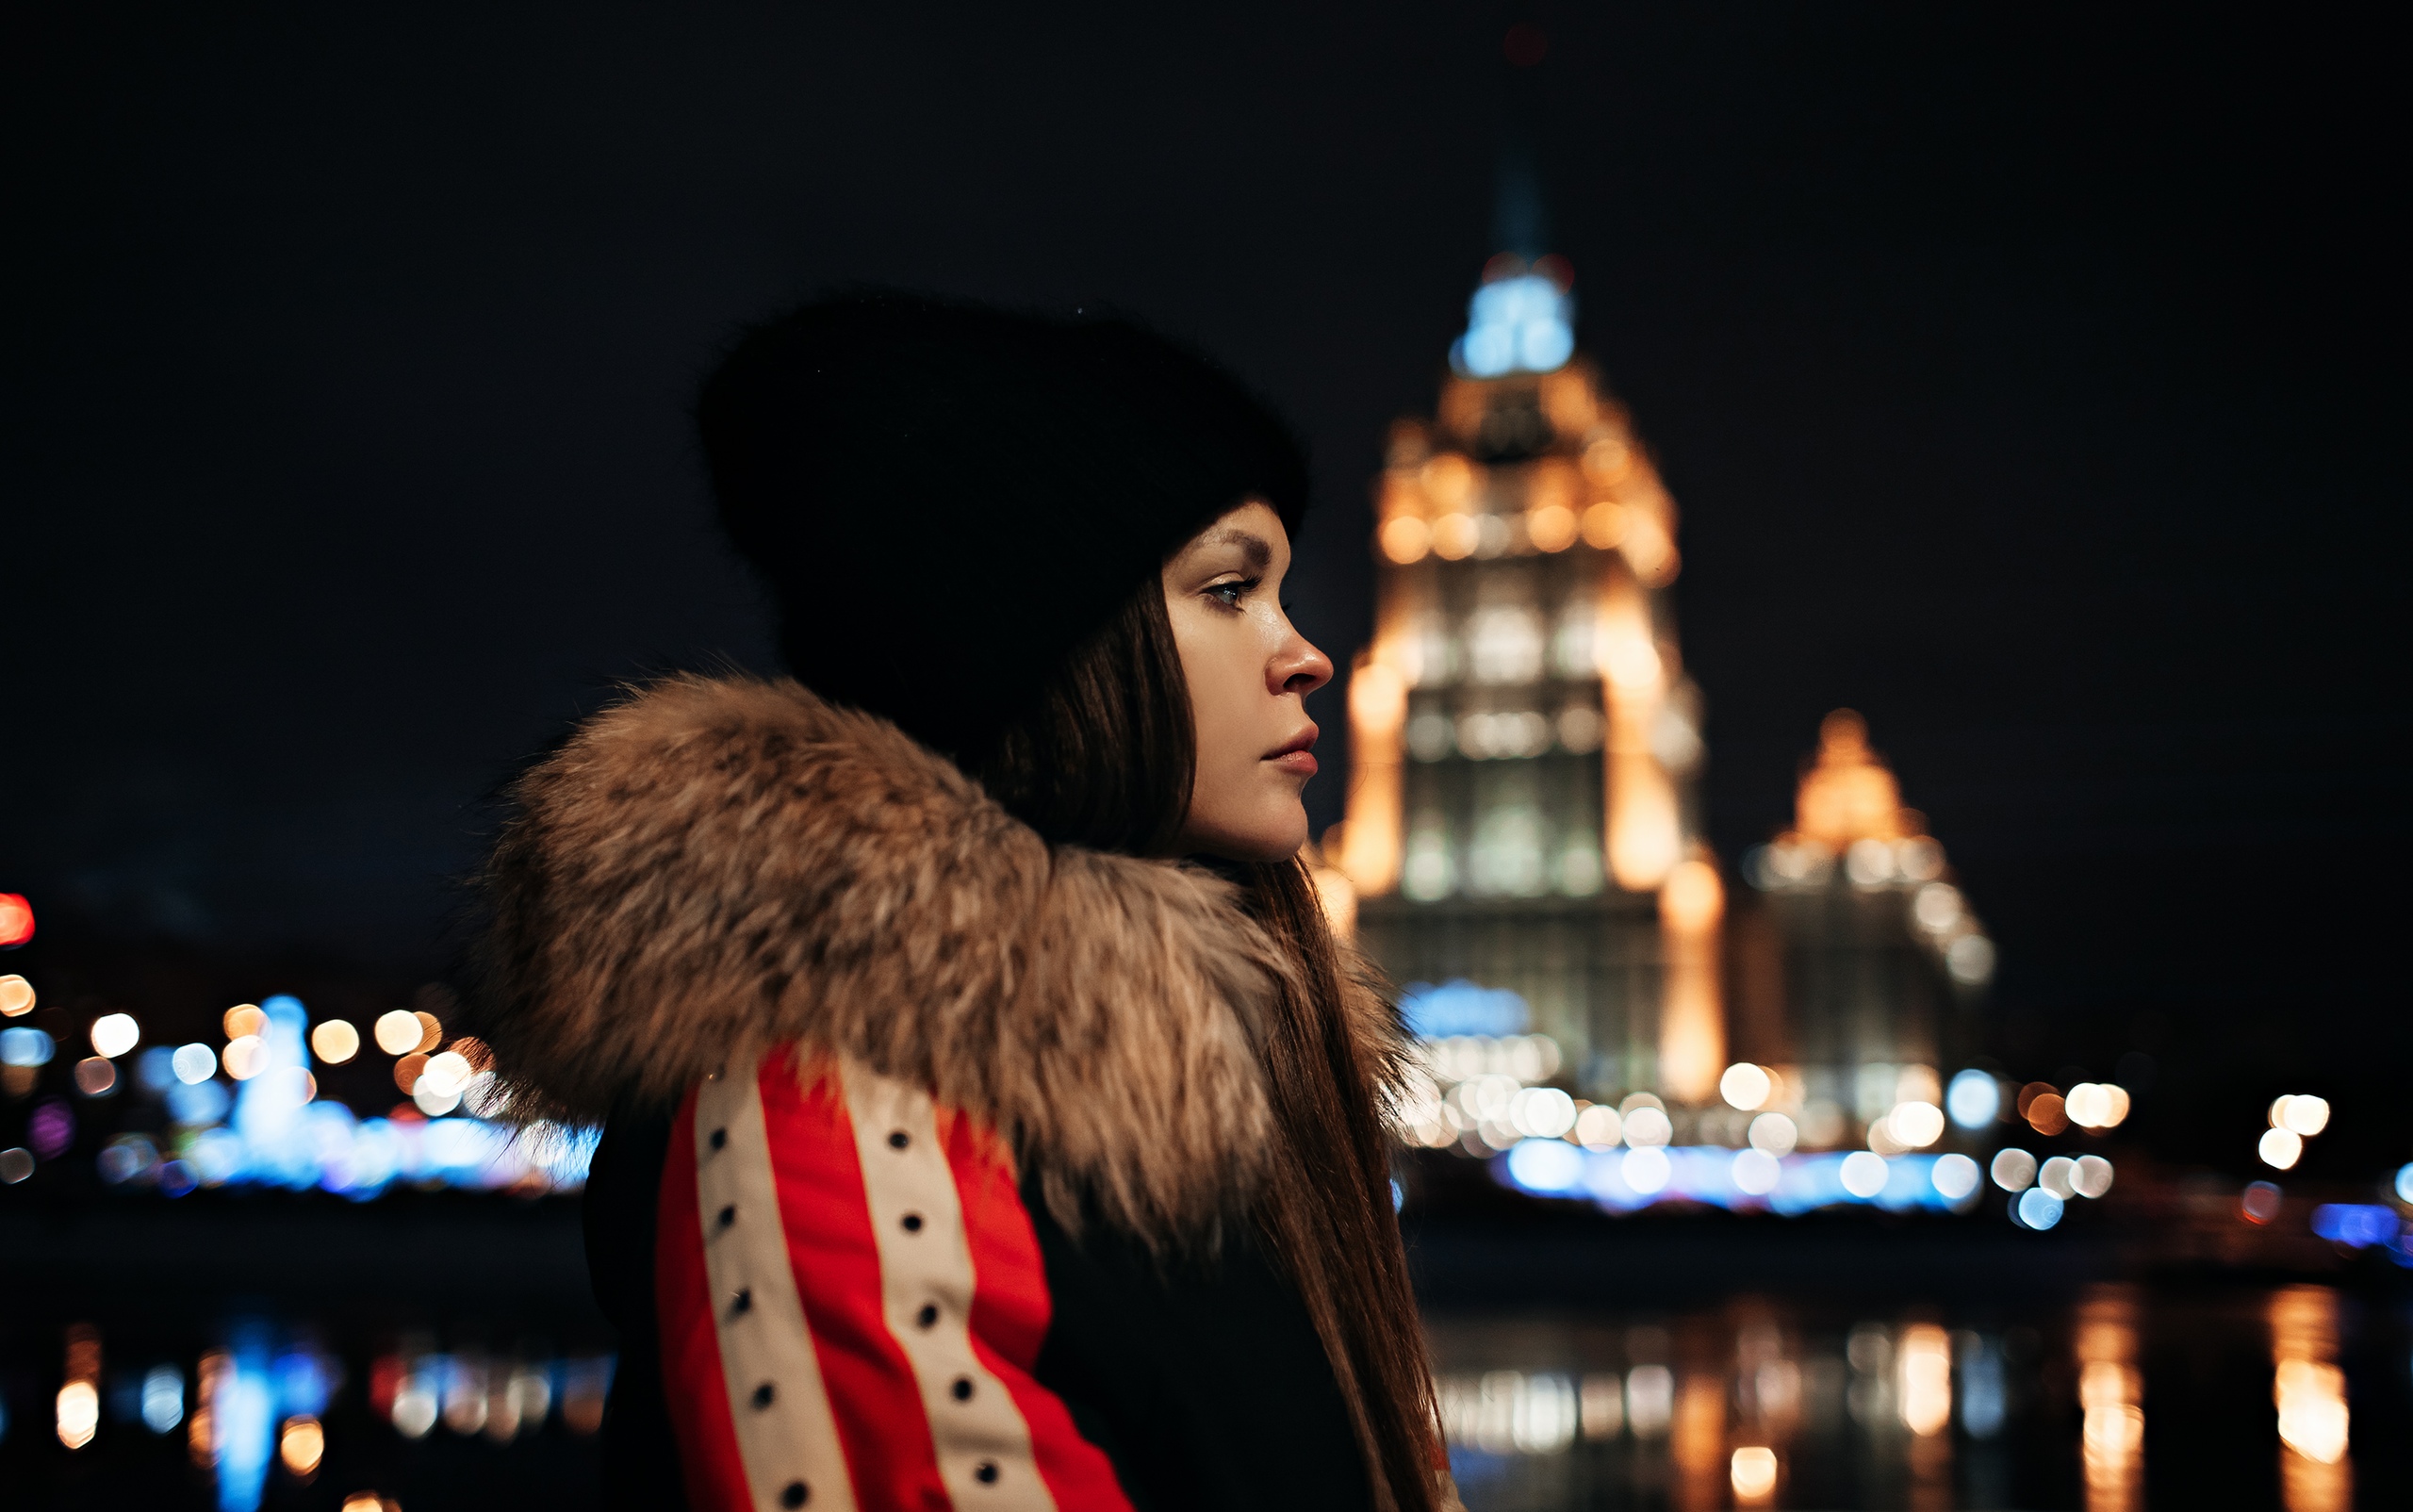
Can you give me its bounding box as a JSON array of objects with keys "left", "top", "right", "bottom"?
[{"left": 0, "top": 1286, "right": 2413, "bottom": 1512}]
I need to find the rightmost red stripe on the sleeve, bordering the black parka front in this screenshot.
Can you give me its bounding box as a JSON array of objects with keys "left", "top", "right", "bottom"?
[{"left": 944, "top": 1116, "right": 1132, "bottom": 1512}]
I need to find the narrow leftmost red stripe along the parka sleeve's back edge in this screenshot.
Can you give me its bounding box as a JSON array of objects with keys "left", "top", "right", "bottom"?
[{"left": 654, "top": 1093, "right": 753, "bottom": 1512}]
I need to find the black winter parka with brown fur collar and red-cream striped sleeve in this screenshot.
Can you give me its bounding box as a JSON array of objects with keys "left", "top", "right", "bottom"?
[{"left": 480, "top": 678, "right": 1437, "bottom": 1512}]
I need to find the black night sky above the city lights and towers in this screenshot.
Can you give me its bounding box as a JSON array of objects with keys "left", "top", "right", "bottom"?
[{"left": 0, "top": 5, "right": 2413, "bottom": 1160}]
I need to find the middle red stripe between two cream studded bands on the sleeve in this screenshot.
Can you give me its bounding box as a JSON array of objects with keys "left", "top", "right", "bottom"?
[{"left": 760, "top": 1054, "right": 948, "bottom": 1512}]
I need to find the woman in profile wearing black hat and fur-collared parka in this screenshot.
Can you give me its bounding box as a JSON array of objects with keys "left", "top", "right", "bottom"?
[{"left": 480, "top": 294, "right": 1455, "bottom": 1512}]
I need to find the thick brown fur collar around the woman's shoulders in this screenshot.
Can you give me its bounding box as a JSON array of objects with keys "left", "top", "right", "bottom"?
[{"left": 475, "top": 675, "right": 1400, "bottom": 1235}]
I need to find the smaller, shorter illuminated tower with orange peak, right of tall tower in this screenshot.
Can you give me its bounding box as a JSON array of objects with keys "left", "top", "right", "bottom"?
[{"left": 1735, "top": 709, "right": 1994, "bottom": 1150}]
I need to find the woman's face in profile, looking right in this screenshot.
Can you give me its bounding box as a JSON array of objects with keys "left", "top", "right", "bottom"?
[{"left": 1165, "top": 504, "right": 1332, "bottom": 861}]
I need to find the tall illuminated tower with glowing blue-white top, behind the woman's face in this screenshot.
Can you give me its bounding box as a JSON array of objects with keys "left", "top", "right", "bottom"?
[{"left": 1327, "top": 254, "right": 1725, "bottom": 1105}]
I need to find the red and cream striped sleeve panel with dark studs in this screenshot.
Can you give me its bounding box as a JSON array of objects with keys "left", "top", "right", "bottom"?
[{"left": 654, "top": 1051, "right": 1129, "bottom": 1512}]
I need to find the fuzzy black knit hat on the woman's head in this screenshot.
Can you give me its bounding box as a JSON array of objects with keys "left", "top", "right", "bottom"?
[{"left": 695, "top": 292, "right": 1308, "bottom": 755}]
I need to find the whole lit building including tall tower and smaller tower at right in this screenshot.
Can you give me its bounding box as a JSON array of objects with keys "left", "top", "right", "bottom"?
[{"left": 1324, "top": 254, "right": 1994, "bottom": 1184}]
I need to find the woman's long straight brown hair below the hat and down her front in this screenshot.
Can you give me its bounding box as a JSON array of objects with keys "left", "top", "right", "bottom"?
[{"left": 965, "top": 579, "right": 1438, "bottom": 1512}]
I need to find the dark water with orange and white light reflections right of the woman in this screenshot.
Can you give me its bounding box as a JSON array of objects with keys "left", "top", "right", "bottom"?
[{"left": 1429, "top": 1286, "right": 2413, "bottom": 1512}]
